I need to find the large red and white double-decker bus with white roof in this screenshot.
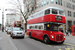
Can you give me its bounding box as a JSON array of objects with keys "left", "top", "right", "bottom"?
[{"left": 27, "top": 7, "right": 66, "bottom": 44}]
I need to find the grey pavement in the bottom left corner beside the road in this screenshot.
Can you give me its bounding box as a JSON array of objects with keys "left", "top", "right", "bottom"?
[{"left": 0, "top": 31, "right": 17, "bottom": 50}]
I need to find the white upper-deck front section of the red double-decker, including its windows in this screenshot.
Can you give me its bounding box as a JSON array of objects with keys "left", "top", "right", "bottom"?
[{"left": 44, "top": 7, "right": 65, "bottom": 16}]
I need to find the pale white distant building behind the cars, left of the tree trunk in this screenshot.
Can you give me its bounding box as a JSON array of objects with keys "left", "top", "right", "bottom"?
[{"left": 6, "top": 13, "right": 21, "bottom": 26}]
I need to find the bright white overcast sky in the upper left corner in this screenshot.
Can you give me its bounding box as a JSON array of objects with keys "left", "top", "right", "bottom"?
[{"left": 0, "top": 0, "right": 23, "bottom": 25}]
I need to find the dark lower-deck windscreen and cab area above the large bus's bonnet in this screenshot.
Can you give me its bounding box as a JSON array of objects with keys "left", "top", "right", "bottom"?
[{"left": 44, "top": 22, "right": 63, "bottom": 32}]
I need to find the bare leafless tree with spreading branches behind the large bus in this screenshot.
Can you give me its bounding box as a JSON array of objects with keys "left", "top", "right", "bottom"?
[{"left": 10, "top": 0, "right": 36, "bottom": 30}]
